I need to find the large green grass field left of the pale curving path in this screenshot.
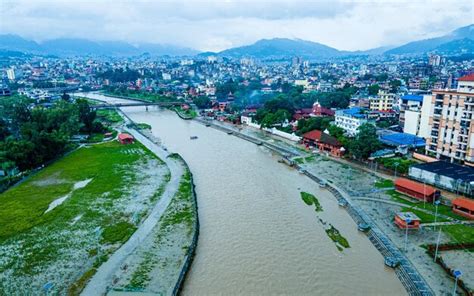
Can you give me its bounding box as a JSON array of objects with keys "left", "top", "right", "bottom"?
[{"left": 0, "top": 141, "right": 167, "bottom": 294}]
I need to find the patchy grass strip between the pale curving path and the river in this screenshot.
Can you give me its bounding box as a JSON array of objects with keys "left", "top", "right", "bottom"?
[{"left": 109, "top": 155, "right": 199, "bottom": 295}]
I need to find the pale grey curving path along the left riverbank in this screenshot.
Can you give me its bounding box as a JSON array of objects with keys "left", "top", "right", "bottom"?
[{"left": 81, "top": 114, "right": 184, "bottom": 296}]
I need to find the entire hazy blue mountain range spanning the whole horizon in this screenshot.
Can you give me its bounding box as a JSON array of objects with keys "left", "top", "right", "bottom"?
[{"left": 0, "top": 24, "right": 474, "bottom": 60}]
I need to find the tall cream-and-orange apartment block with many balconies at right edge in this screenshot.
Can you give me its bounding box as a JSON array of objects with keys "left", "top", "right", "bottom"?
[{"left": 426, "top": 73, "right": 474, "bottom": 166}]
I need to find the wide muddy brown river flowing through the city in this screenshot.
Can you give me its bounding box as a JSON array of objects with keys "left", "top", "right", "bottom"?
[{"left": 78, "top": 94, "right": 406, "bottom": 295}]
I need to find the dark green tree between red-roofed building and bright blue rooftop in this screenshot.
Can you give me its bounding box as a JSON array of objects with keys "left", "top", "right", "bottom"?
[{"left": 349, "top": 123, "right": 382, "bottom": 159}]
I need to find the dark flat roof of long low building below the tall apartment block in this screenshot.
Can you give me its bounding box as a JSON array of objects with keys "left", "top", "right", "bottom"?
[{"left": 412, "top": 161, "right": 474, "bottom": 183}]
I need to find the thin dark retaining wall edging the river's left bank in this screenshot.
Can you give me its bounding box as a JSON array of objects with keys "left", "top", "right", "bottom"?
[{"left": 118, "top": 109, "right": 200, "bottom": 296}]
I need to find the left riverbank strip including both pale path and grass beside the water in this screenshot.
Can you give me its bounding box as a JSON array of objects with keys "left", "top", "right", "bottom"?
[{"left": 82, "top": 112, "right": 199, "bottom": 295}]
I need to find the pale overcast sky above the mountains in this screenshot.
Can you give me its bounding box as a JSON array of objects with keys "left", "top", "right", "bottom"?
[{"left": 0, "top": 0, "right": 474, "bottom": 51}]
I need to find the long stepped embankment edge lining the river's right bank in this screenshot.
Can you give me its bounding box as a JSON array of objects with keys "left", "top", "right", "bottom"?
[{"left": 195, "top": 118, "right": 434, "bottom": 296}]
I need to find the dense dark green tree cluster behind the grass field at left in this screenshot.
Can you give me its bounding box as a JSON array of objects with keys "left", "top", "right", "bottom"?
[{"left": 0, "top": 96, "right": 104, "bottom": 171}]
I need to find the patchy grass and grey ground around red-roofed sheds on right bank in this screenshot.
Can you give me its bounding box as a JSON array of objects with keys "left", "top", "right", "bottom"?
[{"left": 300, "top": 154, "right": 474, "bottom": 295}]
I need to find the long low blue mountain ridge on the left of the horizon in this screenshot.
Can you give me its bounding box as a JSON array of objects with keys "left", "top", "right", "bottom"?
[{"left": 0, "top": 34, "right": 199, "bottom": 56}]
